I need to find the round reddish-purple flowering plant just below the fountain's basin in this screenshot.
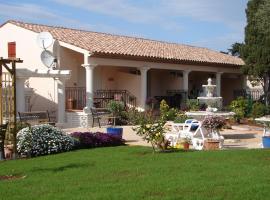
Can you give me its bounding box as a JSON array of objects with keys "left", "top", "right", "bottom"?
[{"left": 202, "top": 116, "right": 225, "bottom": 132}]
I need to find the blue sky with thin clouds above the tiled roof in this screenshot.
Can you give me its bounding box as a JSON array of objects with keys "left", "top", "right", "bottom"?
[{"left": 0, "top": 0, "right": 248, "bottom": 51}]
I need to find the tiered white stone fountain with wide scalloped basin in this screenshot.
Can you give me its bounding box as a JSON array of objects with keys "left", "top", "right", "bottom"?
[{"left": 186, "top": 78, "right": 235, "bottom": 120}]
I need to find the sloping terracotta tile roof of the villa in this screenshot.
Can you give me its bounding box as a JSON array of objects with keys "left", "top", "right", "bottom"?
[{"left": 7, "top": 21, "right": 244, "bottom": 65}]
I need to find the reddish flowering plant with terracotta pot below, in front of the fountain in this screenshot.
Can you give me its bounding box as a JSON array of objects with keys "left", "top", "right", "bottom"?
[{"left": 202, "top": 116, "right": 225, "bottom": 150}]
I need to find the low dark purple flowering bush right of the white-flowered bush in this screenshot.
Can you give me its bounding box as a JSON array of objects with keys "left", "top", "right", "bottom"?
[{"left": 71, "top": 132, "right": 124, "bottom": 148}]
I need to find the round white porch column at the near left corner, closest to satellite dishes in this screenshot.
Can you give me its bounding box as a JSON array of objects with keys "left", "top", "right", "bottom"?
[{"left": 82, "top": 64, "right": 96, "bottom": 113}]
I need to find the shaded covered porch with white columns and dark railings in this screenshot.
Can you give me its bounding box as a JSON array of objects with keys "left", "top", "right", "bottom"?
[{"left": 62, "top": 45, "right": 245, "bottom": 113}]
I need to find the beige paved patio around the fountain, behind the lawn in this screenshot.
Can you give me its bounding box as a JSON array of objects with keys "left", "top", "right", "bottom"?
[{"left": 64, "top": 125, "right": 263, "bottom": 149}]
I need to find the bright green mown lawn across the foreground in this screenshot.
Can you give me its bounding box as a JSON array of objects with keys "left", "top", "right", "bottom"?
[{"left": 0, "top": 146, "right": 270, "bottom": 200}]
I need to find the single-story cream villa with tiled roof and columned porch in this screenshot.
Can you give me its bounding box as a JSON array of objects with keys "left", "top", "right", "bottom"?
[{"left": 0, "top": 21, "right": 246, "bottom": 126}]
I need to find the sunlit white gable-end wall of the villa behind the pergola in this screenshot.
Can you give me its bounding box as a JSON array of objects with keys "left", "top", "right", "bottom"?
[{"left": 0, "top": 23, "right": 57, "bottom": 114}]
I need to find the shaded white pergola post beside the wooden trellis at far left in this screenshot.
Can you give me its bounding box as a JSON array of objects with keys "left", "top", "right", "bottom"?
[{"left": 16, "top": 77, "right": 26, "bottom": 112}]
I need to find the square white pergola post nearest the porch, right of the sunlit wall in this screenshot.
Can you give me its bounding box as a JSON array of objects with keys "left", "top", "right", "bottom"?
[{"left": 57, "top": 78, "right": 66, "bottom": 125}]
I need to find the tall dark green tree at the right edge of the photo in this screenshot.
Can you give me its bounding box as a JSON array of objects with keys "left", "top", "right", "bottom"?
[{"left": 240, "top": 0, "right": 270, "bottom": 105}]
